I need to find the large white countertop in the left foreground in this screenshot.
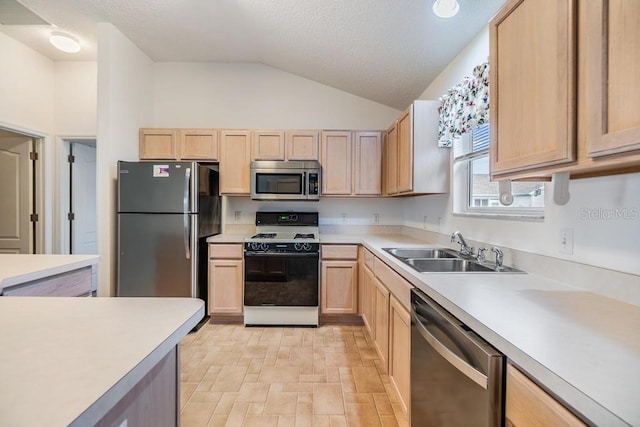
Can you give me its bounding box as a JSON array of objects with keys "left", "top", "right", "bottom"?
[{"left": 0, "top": 297, "right": 204, "bottom": 427}]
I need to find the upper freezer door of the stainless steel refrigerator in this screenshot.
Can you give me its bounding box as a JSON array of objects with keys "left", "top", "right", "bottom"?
[{"left": 118, "top": 161, "right": 197, "bottom": 213}]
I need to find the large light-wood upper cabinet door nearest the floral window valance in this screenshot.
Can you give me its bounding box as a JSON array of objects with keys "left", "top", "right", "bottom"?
[{"left": 489, "top": 0, "right": 577, "bottom": 177}]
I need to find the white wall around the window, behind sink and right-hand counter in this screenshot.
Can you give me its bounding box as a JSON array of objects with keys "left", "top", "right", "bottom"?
[{"left": 403, "top": 25, "right": 640, "bottom": 274}]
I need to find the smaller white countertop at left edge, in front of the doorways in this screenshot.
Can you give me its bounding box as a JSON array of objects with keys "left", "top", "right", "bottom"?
[{"left": 0, "top": 254, "right": 99, "bottom": 293}]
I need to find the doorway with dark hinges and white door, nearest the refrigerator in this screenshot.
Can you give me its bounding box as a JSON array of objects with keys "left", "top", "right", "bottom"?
[{"left": 59, "top": 138, "right": 98, "bottom": 255}]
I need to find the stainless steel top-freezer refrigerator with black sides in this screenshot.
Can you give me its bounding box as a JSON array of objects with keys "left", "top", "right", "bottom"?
[{"left": 117, "top": 161, "right": 221, "bottom": 301}]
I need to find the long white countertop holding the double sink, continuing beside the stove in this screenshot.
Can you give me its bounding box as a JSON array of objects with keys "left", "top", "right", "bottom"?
[{"left": 210, "top": 233, "right": 640, "bottom": 426}]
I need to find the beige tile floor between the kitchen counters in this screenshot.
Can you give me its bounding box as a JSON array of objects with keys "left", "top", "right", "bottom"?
[{"left": 180, "top": 324, "right": 408, "bottom": 427}]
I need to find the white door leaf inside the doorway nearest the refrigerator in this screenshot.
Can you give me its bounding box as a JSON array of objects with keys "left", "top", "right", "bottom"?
[{"left": 71, "top": 143, "right": 98, "bottom": 255}]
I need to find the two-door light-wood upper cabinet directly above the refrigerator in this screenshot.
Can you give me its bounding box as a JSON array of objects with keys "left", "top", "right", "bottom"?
[{"left": 139, "top": 129, "right": 219, "bottom": 161}]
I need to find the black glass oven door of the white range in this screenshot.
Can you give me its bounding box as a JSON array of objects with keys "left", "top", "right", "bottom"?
[{"left": 244, "top": 252, "right": 320, "bottom": 307}]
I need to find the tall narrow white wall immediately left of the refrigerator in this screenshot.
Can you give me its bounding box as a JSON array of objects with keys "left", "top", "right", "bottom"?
[{"left": 96, "top": 24, "right": 153, "bottom": 296}]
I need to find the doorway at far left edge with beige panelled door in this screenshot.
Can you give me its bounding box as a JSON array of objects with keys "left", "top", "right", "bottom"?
[{"left": 0, "top": 128, "right": 41, "bottom": 254}]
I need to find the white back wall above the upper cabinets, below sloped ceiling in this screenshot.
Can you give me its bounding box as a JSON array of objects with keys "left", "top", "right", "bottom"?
[{"left": 152, "top": 62, "right": 400, "bottom": 130}]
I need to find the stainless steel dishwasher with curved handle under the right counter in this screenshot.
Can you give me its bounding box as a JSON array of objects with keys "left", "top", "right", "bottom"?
[{"left": 411, "top": 289, "right": 505, "bottom": 427}]
